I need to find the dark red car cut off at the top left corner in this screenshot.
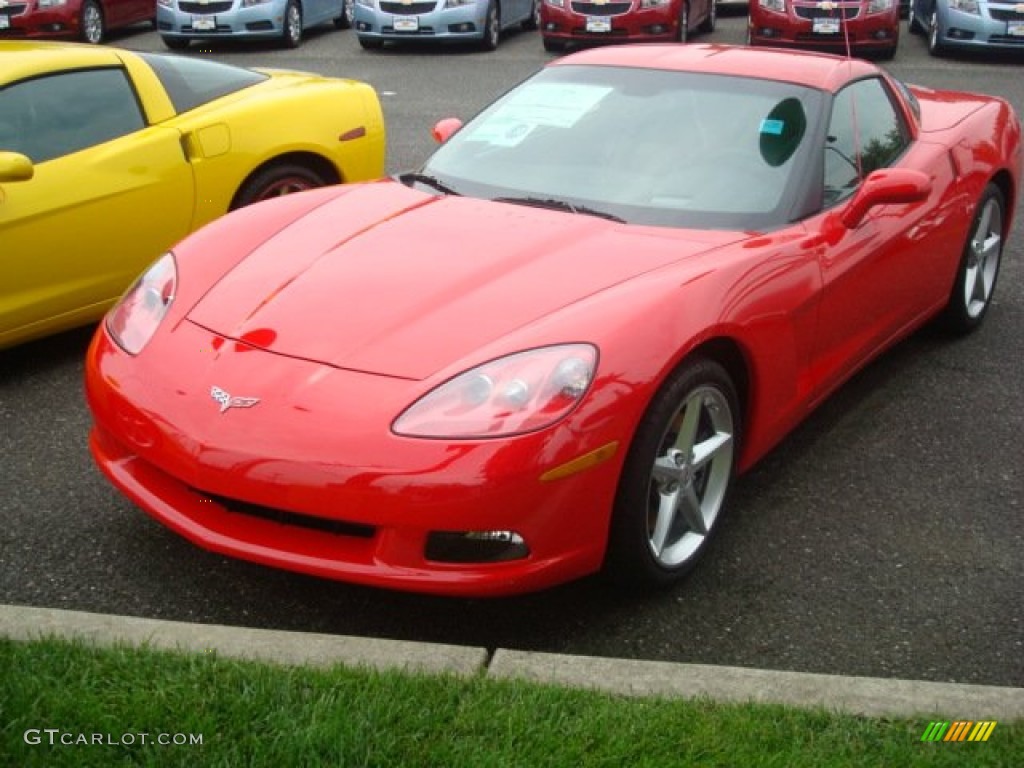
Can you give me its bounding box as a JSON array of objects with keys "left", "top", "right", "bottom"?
[{"left": 0, "top": 0, "right": 157, "bottom": 43}]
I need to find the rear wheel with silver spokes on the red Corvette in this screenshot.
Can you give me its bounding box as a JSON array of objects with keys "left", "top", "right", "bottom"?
[{"left": 939, "top": 183, "right": 1007, "bottom": 335}]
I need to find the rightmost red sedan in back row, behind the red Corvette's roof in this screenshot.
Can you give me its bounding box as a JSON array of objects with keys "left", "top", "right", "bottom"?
[{"left": 746, "top": 0, "right": 900, "bottom": 58}]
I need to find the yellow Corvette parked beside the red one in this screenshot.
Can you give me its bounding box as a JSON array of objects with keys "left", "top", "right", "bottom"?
[{"left": 0, "top": 42, "right": 385, "bottom": 348}]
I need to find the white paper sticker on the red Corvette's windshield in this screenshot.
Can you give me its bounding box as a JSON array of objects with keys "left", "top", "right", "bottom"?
[{"left": 468, "top": 83, "right": 611, "bottom": 146}]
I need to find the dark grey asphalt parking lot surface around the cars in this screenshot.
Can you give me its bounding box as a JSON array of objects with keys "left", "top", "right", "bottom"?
[{"left": 0, "top": 16, "right": 1024, "bottom": 686}]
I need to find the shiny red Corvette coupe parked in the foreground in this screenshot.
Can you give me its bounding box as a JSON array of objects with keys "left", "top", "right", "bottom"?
[{"left": 86, "top": 45, "right": 1022, "bottom": 595}]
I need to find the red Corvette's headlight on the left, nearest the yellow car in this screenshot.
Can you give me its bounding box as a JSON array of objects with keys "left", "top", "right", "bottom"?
[{"left": 106, "top": 253, "right": 178, "bottom": 354}]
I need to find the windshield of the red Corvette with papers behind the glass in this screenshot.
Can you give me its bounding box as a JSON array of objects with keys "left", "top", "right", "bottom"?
[{"left": 422, "top": 66, "right": 822, "bottom": 229}]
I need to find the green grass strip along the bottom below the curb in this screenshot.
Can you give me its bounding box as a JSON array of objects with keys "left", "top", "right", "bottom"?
[{"left": 0, "top": 639, "right": 1024, "bottom": 768}]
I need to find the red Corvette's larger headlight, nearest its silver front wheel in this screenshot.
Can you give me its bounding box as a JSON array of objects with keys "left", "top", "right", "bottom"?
[{"left": 392, "top": 344, "right": 597, "bottom": 439}]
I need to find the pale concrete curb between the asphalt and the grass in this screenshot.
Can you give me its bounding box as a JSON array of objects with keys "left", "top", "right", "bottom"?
[{"left": 0, "top": 605, "right": 1024, "bottom": 720}]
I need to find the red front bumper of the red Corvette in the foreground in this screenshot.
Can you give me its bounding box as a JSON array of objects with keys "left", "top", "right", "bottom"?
[{"left": 86, "top": 322, "right": 621, "bottom": 596}]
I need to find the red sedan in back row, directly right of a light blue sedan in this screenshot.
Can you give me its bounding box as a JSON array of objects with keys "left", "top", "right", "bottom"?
[{"left": 540, "top": 0, "right": 717, "bottom": 52}]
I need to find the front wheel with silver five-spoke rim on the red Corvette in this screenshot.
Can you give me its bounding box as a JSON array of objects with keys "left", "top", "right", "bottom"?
[{"left": 605, "top": 357, "right": 740, "bottom": 588}]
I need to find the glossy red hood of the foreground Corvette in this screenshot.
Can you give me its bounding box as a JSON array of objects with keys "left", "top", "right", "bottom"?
[{"left": 188, "top": 182, "right": 742, "bottom": 379}]
